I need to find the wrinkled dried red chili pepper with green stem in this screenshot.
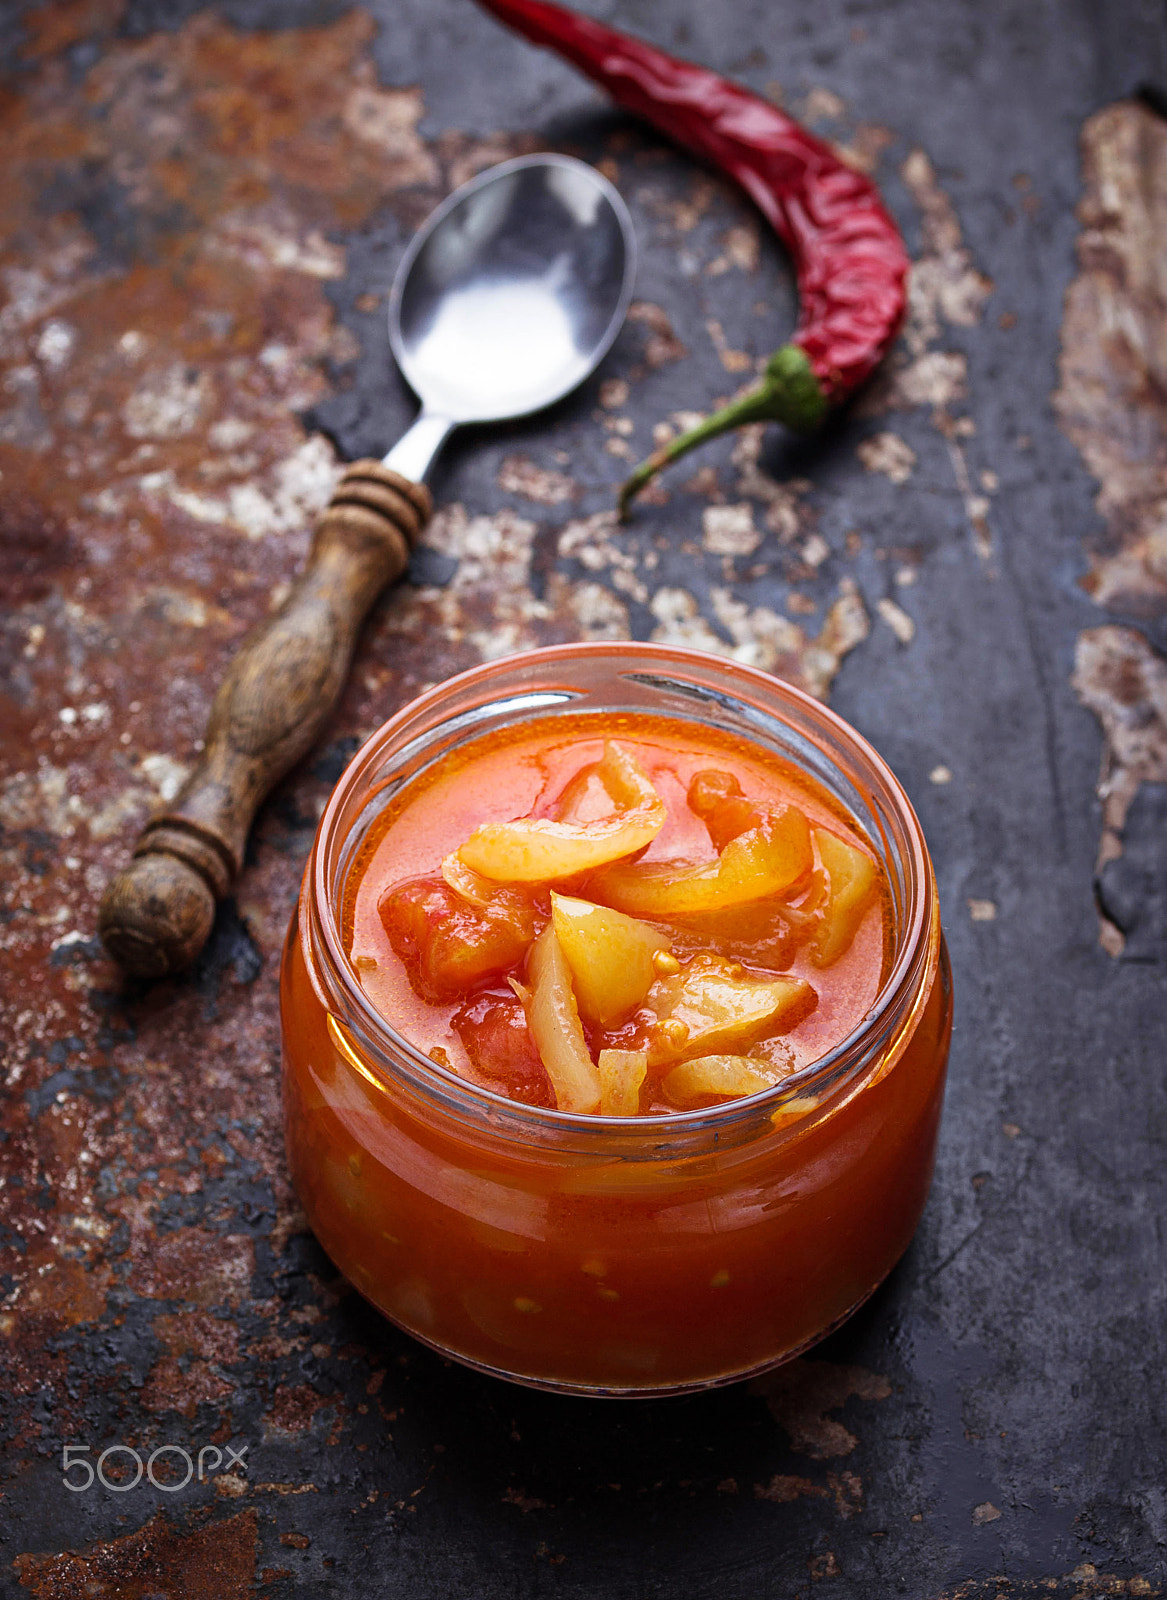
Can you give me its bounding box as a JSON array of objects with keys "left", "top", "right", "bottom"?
[{"left": 467, "top": 0, "right": 909, "bottom": 510}]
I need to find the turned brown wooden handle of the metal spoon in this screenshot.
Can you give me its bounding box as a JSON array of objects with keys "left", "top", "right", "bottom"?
[{"left": 98, "top": 461, "right": 431, "bottom": 978}]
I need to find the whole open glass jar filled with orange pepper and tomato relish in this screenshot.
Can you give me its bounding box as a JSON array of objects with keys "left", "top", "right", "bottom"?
[{"left": 280, "top": 643, "right": 952, "bottom": 1395}]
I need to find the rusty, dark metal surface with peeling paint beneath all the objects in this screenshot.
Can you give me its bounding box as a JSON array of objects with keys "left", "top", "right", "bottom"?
[{"left": 0, "top": 0, "right": 1167, "bottom": 1600}]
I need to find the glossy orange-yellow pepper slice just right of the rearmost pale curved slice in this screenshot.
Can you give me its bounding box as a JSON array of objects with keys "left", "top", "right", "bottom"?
[{"left": 588, "top": 806, "right": 815, "bottom": 918}]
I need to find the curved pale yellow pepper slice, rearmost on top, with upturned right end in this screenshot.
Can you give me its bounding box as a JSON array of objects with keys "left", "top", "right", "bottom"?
[{"left": 458, "top": 741, "right": 664, "bottom": 883}]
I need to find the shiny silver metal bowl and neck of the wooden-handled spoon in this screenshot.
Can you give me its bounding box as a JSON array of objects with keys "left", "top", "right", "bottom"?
[{"left": 384, "top": 154, "right": 636, "bottom": 482}]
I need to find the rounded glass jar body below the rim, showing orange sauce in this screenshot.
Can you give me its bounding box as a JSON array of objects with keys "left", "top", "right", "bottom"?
[{"left": 282, "top": 646, "right": 951, "bottom": 1394}]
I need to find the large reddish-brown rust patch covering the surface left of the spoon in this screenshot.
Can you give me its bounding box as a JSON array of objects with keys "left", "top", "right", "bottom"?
[{"left": 0, "top": 0, "right": 525, "bottom": 1438}]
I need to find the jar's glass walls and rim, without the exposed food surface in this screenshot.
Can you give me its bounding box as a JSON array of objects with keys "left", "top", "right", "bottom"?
[{"left": 282, "top": 643, "right": 952, "bottom": 1395}]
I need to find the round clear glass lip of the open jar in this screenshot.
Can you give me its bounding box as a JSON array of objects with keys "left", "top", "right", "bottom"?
[{"left": 306, "top": 640, "right": 936, "bottom": 1144}]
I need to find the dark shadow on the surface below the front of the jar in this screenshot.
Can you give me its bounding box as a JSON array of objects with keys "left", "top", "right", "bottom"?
[{"left": 320, "top": 1262, "right": 911, "bottom": 1561}]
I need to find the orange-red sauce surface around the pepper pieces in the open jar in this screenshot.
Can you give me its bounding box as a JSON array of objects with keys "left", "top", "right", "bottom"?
[{"left": 341, "top": 714, "right": 890, "bottom": 1114}]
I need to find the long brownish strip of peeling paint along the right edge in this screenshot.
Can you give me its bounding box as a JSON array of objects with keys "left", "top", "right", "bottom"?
[{"left": 1053, "top": 101, "right": 1167, "bottom": 957}]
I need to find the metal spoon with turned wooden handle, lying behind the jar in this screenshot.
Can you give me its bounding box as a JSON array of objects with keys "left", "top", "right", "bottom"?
[{"left": 98, "top": 155, "right": 636, "bottom": 978}]
